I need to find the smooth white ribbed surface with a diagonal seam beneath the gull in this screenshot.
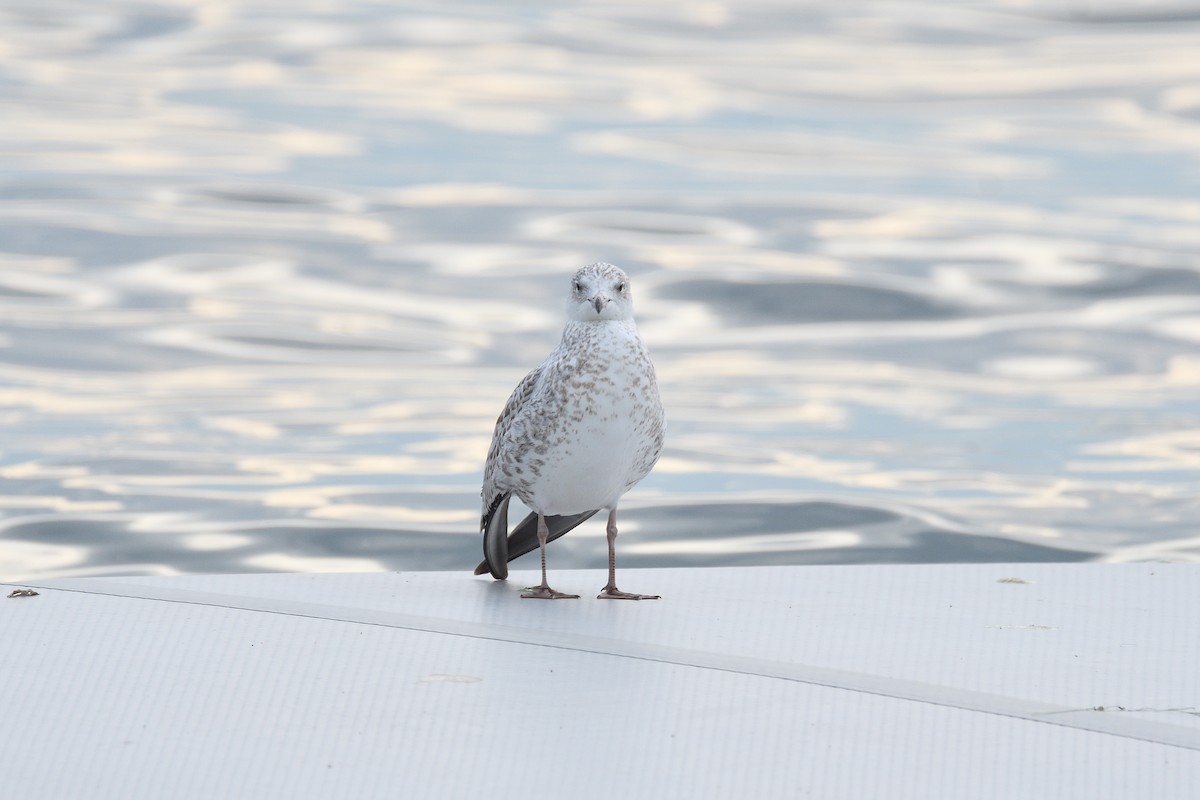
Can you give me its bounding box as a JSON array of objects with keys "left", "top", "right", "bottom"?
[{"left": 0, "top": 564, "right": 1200, "bottom": 800}]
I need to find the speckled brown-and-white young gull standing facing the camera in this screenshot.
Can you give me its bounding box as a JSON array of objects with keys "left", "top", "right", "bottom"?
[{"left": 475, "top": 261, "right": 665, "bottom": 600}]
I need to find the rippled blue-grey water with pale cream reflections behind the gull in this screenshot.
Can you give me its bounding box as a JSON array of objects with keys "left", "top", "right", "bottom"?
[{"left": 0, "top": 0, "right": 1200, "bottom": 579}]
